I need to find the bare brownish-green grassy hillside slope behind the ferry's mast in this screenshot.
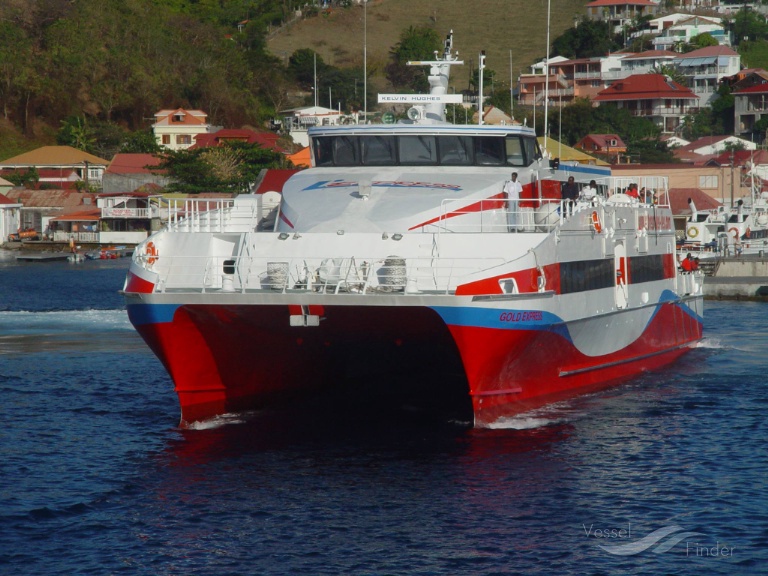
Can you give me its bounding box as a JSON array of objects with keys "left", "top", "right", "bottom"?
[{"left": 268, "top": 0, "right": 586, "bottom": 90}]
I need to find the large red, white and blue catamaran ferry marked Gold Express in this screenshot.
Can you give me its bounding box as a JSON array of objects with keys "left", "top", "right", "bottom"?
[{"left": 124, "top": 36, "right": 703, "bottom": 426}]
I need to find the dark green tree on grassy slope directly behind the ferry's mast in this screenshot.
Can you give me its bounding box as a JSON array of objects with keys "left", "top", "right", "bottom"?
[{"left": 385, "top": 26, "right": 442, "bottom": 92}]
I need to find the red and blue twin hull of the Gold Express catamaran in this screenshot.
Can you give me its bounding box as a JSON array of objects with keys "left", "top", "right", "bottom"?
[{"left": 128, "top": 296, "right": 702, "bottom": 426}]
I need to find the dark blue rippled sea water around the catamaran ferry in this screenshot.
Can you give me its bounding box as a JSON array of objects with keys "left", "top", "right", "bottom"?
[{"left": 0, "top": 251, "right": 768, "bottom": 575}]
